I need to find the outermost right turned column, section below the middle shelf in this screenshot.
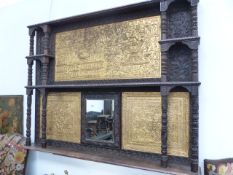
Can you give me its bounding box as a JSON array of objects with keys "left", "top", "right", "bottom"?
[{"left": 190, "top": 86, "right": 199, "bottom": 172}]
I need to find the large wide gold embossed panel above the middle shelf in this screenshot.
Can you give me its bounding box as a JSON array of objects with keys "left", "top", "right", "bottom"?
[{"left": 55, "top": 16, "right": 161, "bottom": 81}]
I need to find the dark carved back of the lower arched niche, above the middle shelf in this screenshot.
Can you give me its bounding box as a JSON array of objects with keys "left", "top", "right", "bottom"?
[{"left": 167, "top": 44, "right": 192, "bottom": 81}]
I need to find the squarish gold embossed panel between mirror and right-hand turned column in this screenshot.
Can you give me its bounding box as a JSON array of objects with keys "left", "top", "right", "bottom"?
[{"left": 122, "top": 92, "right": 161, "bottom": 153}]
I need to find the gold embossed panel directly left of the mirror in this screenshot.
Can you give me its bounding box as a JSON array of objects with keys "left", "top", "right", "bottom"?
[{"left": 41, "top": 92, "right": 81, "bottom": 143}]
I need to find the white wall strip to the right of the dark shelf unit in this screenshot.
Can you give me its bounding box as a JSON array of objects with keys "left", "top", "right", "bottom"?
[{"left": 199, "top": 0, "right": 233, "bottom": 164}]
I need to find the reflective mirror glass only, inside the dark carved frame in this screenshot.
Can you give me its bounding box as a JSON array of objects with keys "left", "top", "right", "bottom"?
[{"left": 85, "top": 99, "right": 114, "bottom": 142}]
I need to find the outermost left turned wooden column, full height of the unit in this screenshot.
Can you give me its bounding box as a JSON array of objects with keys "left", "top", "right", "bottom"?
[{"left": 26, "top": 28, "right": 35, "bottom": 146}]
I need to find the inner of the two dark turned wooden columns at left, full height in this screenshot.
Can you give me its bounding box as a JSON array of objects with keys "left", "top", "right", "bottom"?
[{"left": 41, "top": 25, "right": 50, "bottom": 148}]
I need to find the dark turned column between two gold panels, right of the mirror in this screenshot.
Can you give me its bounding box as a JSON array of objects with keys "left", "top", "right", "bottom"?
[{"left": 161, "top": 87, "right": 168, "bottom": 168}]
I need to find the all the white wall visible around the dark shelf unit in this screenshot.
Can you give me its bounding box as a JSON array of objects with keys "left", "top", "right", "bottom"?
[{"left": 0, "top": 0, "right": 233, "bottom": 175}]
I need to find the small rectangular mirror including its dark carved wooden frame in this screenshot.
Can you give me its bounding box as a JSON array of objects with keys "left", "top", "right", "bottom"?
[{"left": 82, "top": 93, "right": 120, "bottom": 147}]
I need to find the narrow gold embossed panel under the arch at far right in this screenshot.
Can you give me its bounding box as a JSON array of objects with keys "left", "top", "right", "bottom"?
[{"left": 168, "top": 92, "right": 190, "bottom": 157}]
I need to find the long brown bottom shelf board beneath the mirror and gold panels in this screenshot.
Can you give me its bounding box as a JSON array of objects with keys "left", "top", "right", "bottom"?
[{"left": 25, "top": 146, "right": 197, "bottom": 175}]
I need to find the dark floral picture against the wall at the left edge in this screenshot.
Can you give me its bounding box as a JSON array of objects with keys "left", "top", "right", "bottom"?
[{"left": 0, "top": 95, "right": 23, "bottom": 134}]
